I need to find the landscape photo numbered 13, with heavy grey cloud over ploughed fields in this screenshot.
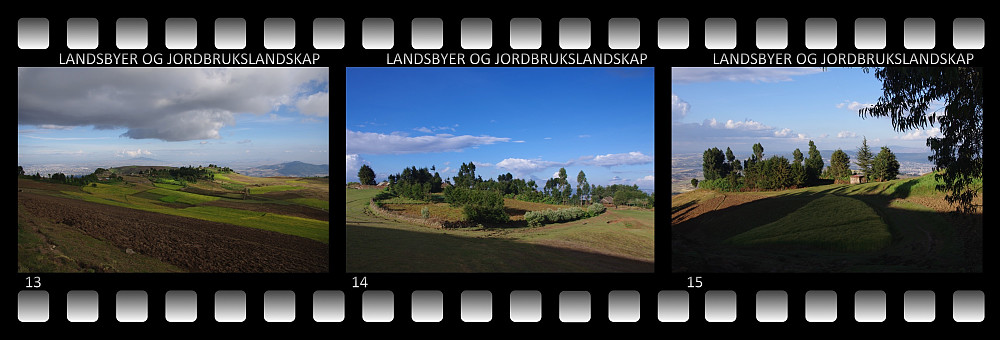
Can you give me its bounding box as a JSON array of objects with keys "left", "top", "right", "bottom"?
[{"left": 17, "top": 68, "right": 331, "bottom": 273}]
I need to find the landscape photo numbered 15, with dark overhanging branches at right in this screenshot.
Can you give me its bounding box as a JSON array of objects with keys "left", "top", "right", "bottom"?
[{"left": 670, "top": 67, "right": 983, "bottom": 273}]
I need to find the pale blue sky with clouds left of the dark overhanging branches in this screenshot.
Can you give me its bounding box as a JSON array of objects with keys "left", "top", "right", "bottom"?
[{"left": 671, "top": 68, "right": 943, "bottom": 155}]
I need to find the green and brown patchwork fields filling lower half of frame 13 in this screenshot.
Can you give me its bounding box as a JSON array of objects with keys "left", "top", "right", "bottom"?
[{"left": 18, "top": 174, "right": 330, "bottom": 272}]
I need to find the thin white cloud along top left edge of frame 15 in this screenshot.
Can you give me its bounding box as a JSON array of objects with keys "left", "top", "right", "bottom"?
[{"left": 670, "top": 67, "right": 823, "bottom": 83}]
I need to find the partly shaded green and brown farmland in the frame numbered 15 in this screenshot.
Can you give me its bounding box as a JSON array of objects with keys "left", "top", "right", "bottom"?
[{"left": 671, "top": 175, "right": 983, "bottom": 272}]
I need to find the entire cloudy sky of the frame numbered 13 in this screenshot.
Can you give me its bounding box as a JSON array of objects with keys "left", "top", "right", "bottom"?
[{"left": 17, "top": 68, "right": 330, "bottom": 165}]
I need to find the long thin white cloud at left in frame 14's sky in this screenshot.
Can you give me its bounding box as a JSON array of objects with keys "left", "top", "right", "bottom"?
[{"left": 346, "top": 130, "right": 510, "bottom": 154}]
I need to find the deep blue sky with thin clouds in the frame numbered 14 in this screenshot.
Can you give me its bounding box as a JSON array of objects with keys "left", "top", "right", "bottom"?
[{"left": 346, "top": 68, "right": 655, "bottom": 189}]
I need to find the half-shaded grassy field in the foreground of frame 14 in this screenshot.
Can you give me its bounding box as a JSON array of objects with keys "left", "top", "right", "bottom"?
[{"left": 346, "top": 189, "right": 655, "bottom": 273}]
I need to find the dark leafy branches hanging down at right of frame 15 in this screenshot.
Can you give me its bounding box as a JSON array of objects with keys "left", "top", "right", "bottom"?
[{"left": 858, "top": 67, "right": 984, "bottom": 212}]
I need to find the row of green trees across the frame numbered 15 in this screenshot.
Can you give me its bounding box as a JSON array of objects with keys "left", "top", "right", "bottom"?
[{"left": 691, "top": 138, "right": 899, "bottom": 191}]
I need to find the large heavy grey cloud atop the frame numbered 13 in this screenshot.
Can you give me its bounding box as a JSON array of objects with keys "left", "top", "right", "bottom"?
[{"left": 17, "top": 68, "right": 329, "bottom": 141}]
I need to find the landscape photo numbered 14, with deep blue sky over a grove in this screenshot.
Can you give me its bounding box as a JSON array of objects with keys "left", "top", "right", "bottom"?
[{"left": 344, "top": 67, "right": 656, "bottom": 273}]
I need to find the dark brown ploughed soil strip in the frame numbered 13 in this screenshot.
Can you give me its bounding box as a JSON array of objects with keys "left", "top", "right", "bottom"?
[{"left": 17, "top": 192, "right": 330, "bottom": 273}]
